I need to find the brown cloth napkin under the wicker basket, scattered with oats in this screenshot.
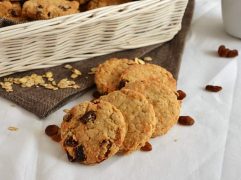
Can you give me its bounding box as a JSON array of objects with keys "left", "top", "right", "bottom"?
[{"left": 0, "top": 0, "right": 194, "bottom": 118}]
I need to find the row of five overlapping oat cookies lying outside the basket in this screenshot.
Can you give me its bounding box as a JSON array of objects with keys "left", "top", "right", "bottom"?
[{"left": 61, "top": 59, "right": 181, "bottom": 164}]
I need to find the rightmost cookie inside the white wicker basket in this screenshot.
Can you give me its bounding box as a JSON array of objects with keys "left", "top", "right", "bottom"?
[{"left": 87, "top": 0, "right": 132, "bottom": 10}]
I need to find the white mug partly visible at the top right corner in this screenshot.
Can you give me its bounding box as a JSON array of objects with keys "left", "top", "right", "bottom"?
[{"left": 222, "top": 0, "right": 241, "bottom": 38}]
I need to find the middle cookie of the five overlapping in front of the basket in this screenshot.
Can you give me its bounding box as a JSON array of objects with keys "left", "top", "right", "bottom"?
[{"left": 123, "top": 78, "right": 181, "bottom": 137}]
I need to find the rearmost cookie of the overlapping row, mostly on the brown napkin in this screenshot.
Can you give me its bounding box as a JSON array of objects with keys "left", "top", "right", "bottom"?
[{"left": 95, "top": 58, "right": 136, "bottom": 94}]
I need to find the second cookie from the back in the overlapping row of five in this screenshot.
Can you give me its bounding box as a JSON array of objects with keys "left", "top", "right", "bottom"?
[{"left": 119, "top": 64, "right": 176, "bottom": 91}]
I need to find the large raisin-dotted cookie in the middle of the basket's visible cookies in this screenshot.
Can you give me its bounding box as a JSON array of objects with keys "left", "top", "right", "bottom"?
[{"left": 22, "top": 0, "right": 79, "bottom": 20}]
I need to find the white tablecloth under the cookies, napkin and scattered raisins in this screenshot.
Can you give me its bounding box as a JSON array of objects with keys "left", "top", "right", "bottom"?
[{"left": 0, "top": 0, "right": 241, "bottom": 180}]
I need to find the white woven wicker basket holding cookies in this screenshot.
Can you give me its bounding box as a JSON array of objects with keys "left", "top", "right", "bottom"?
[{"left": 0, "top": 0, "right": 188, "bottom": 77}]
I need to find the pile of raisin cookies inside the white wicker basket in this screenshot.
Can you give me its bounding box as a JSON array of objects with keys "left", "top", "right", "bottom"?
[{"left": 0, "top": 0, "right": 131, "bottom": 22}]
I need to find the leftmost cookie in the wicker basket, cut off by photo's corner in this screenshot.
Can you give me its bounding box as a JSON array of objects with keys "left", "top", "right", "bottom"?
[{"left": 0, "top": 0, "right": 24, "bottom": 22}]
